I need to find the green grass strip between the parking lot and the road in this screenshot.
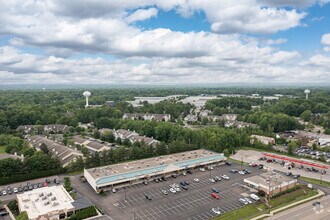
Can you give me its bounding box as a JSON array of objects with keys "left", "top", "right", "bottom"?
[{"left": 214, "top": 187, "right": 317, "bottom": 220}]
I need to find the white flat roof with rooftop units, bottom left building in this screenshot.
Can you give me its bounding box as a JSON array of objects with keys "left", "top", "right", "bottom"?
[{"left": 17, "top": 186, "right": 74, "bottom": 219}]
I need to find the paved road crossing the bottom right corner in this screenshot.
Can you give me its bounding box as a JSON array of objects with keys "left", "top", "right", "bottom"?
[{"left": 266, "top": 196, "right": 330, "bottom": 220}]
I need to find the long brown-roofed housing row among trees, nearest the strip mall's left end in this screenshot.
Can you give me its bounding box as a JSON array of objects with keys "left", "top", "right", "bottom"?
[{"left": 27, "top": 135, "right": 83, "bottom": 167}]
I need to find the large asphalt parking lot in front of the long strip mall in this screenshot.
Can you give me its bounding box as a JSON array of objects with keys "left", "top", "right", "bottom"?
[{"left": 72, "top": 164, "right": 263, "bottom": 220}]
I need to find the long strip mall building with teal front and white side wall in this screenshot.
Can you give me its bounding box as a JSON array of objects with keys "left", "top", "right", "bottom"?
[{"left": 84, "top": 150, "right": 226, "bottom": 192}]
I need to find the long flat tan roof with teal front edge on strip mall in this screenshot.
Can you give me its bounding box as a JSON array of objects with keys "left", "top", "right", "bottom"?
[{"left": 86, "top": 150, "right": 226, "bottom": 184}]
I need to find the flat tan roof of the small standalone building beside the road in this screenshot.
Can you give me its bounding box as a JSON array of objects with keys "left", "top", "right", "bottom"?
[{"left": 244, "top": 172, "right": 293, "bottom": 188}]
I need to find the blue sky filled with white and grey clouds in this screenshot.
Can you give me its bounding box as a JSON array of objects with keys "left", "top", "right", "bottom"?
[{"left": 0, "top": 0, "right": 330, "bottom": 85}]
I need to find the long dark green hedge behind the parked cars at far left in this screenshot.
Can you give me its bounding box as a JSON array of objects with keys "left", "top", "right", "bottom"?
[{"left": 0, "top": 168, "right": 66, "bottom": 186}]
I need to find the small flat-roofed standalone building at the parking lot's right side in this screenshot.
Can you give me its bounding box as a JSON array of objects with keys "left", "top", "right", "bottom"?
[{"left": 244, "top": 172, "right": 297, "bottom": 196}]
